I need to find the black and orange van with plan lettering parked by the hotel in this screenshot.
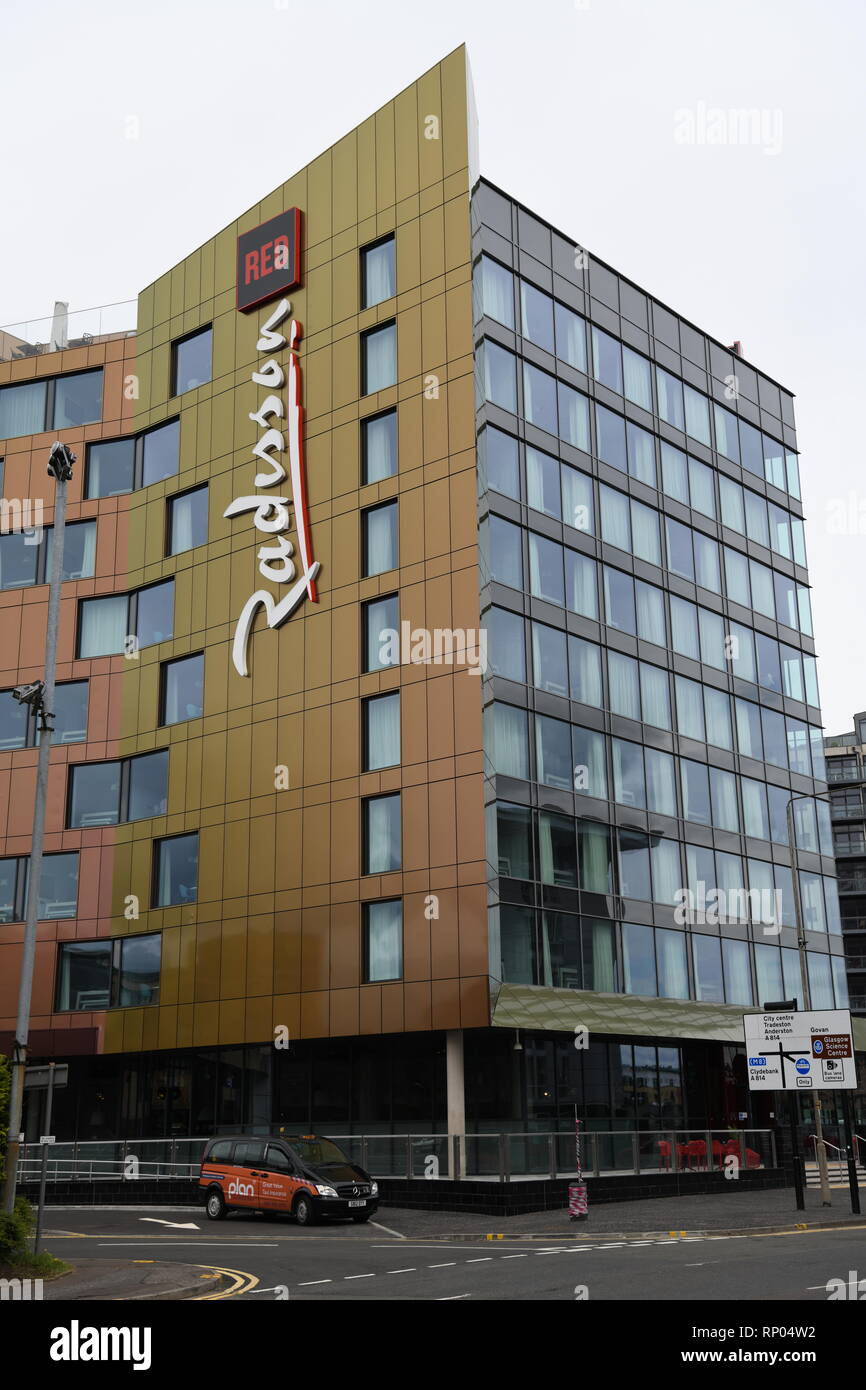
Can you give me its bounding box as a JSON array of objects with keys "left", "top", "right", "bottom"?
[{"left": 199, "top": 1134, "right": 379, "bottom": 1226}]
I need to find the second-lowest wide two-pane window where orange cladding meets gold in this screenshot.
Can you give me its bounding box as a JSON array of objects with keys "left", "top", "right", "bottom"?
[{"left": 67, "top": 749, "right": 168, "bottom": 830}]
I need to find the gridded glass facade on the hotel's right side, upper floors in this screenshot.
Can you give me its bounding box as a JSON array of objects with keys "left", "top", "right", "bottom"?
[{"left": 474, "top": 185, "right": 845, "bottom": 1023}]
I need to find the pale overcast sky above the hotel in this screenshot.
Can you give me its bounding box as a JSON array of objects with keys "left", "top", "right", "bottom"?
[{"left": 0, "top": 0, "right": 866, "bottom": 733}]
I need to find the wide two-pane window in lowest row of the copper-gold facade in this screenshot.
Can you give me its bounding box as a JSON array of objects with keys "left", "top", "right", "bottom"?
[{"left": 56, "top": 933, "right": 163, "bottom": 1012}]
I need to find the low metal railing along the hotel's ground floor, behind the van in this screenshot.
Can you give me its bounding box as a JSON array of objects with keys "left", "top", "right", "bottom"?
[{"left": 18, "top": 1129, "right": 776, "bottom": 1183}]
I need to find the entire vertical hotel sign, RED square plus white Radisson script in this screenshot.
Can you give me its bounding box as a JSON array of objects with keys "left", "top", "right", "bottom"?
[{"left": 222, "top": 207, "right": 320, "bottom": 676}]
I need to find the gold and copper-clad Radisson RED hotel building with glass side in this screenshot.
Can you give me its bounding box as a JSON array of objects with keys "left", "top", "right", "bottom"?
[{"left": 0, "top": 49, "right": 847, "bottom": 1140}]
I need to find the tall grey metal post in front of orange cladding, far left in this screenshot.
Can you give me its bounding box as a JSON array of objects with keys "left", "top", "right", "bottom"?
[{"left": 3, "top": 442, "right": 75, "bottom": 1212}]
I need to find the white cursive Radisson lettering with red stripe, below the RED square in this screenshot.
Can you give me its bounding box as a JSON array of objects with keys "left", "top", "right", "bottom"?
[{"left": 222, "top": 299, "right": 321, "bottom": 676}]
